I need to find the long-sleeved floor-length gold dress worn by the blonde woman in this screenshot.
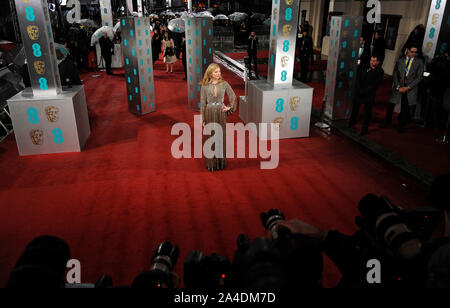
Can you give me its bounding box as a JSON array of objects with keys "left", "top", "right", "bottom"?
[{"left": 200, "top": 81, "right": 236, "bottom": 171}]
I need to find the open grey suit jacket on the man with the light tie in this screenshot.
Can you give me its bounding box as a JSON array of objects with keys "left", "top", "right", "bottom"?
[{"left": 389, "top": 56, "right": 424, "bottom": 106}]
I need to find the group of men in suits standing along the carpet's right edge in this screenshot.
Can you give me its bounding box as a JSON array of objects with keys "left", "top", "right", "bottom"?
[{"left": 349, "top": 25, "right": 450, "bottom": 136}]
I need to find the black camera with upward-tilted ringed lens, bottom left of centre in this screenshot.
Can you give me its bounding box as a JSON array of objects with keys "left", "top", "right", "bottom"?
[{"left": 132, "top": 242, "right": 180, "bottom": 288}]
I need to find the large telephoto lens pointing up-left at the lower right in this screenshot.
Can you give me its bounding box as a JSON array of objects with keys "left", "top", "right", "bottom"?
[{"left": 358, "top": 194, "right": 422, "bottom": 259}]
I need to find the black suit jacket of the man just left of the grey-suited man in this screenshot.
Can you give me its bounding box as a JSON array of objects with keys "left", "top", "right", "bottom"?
[{"left": 355, "top": 65, "right": 384, "bottom": 104}]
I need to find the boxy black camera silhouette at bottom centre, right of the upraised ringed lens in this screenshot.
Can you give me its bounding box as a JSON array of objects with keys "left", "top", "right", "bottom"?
[{"left": 184, "top": 250, "right": 231, "bottom": 288}]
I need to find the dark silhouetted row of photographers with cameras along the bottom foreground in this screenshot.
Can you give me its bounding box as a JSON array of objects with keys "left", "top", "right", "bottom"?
[{"left": 6, "top": 174, "right": 450, "bottom": 289}]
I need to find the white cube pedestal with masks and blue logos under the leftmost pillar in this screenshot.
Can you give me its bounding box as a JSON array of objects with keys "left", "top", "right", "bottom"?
[{"left": 8, "top": 86, "right": 91, "bottom": 156}]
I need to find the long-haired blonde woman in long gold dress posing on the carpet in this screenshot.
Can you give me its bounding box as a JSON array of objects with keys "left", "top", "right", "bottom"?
[{"left": 200, "top": 63, "right": 236, "bottom": 171}]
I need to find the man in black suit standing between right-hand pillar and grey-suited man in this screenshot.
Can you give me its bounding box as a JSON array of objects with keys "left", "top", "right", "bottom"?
[{"left": 349, "top": 55, "right": 384, "bottom": 136}]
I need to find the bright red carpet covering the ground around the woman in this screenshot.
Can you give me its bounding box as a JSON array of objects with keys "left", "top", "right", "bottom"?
[{"left": 0, "top": 62, "right": 427, "bottom": 286}]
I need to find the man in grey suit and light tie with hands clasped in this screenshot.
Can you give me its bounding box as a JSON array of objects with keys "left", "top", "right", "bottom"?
[{"left": 382, "top": 44, "right": 424, "bottom": 133}]
